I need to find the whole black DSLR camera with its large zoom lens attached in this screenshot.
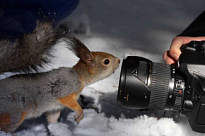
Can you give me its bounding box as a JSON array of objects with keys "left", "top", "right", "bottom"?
[{"left": 117, "top": 41, "right": 205, "bottom": 133}]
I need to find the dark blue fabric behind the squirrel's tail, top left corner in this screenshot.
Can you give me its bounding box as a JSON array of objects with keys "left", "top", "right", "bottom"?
[{"left": 0, "top": 0, "right": 79, "bottom": 39}]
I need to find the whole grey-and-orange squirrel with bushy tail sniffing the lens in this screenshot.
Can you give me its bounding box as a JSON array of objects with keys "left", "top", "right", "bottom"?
[{"left": 0, "top": 22, "right": 120, "bottom": 132}]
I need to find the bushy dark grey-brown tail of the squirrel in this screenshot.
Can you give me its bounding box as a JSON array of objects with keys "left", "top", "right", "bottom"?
[{"left": 0, "top": 22, "right": 67, "bottom": 73}]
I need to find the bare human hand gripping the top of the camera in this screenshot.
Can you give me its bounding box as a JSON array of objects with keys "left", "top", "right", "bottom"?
[{"left": 163, "top": 36, "right": 205, "bottom": 65}]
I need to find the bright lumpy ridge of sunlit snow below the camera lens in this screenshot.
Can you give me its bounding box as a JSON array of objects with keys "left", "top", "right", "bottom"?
[{"left": 65, "top": 109, "right": 182, "bottom": 136}]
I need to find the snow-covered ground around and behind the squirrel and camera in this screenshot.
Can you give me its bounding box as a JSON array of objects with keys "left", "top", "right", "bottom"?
[{"left": 0, "top": 0, "right": 205, "bottom": 136}]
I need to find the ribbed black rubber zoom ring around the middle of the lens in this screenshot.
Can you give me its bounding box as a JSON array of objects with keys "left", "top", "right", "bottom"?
[{"left": 149, "top": 63, "right": 170, "bottom": 110}]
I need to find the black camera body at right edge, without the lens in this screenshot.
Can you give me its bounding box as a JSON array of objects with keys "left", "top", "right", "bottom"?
[{"left": 178, "top": 41, "right": 205, "bottom": 133}]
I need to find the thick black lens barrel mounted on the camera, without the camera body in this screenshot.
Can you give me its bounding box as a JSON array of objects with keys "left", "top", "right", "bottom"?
[{"left": 117, "top": 56, "right": 185, "bottom": 110}]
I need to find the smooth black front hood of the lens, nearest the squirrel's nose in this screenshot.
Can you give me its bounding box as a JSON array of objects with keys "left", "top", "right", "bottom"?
[{"left": 117, "top": 56, "right": 152, "bottom": 109}]
